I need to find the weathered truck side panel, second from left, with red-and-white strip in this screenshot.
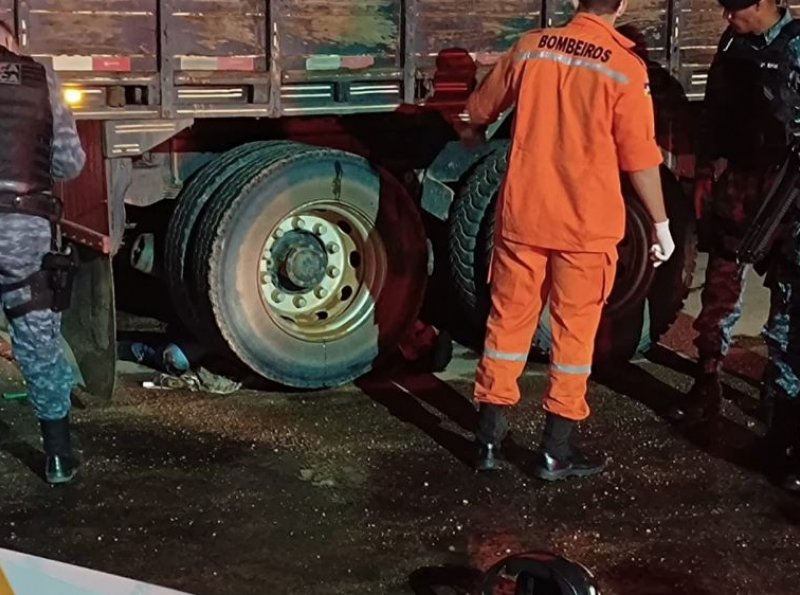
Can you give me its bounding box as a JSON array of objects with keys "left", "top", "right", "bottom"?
[{"left": 169, "top": 0, "right": 268, "bottom": 72}]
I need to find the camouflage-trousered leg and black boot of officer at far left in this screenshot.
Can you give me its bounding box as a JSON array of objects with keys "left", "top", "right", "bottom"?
[{"left": 0, "top": 215, "right": 77, "bottom": 483}]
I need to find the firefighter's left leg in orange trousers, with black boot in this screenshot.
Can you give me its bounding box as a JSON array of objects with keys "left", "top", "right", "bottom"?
[{"left": 475, "top": 237, "right": 548, "bottom": 470}]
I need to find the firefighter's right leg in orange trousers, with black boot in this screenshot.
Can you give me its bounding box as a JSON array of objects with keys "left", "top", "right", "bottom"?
[{"left": 536, "top": 252, "right": 617, "bottom": 481}]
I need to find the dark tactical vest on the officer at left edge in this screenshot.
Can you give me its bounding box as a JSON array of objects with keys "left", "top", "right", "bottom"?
[{"left": 0, "top": 47, "right": 53, "bottom": 194}]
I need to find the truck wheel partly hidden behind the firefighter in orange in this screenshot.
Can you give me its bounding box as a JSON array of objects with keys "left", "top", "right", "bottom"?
[{"left": 449, "top": 141, "right": 697, "bottom": 365}]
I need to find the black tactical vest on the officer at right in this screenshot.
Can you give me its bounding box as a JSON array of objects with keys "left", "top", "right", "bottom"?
[{"left": 721, "top": 20, "right": 800, "bottom": 167}]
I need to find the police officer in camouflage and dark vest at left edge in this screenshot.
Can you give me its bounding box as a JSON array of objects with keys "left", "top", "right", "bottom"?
[{"left": 0, "top": 23, "right": 86, "bottom": 483}]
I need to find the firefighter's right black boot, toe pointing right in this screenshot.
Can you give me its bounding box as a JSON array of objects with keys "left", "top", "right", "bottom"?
[{"left": 534, "top": 412, "right": 605, "bottom": 481}]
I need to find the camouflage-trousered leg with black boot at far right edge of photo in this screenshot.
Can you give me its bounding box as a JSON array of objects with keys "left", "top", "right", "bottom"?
[{"left": 761, "top": 263, "right": 800, "bottom": 492}]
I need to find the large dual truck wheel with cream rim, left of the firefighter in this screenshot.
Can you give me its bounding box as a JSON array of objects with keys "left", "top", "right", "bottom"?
[{"left": 185, "top": 143, "right": 427, "bottom": 388}]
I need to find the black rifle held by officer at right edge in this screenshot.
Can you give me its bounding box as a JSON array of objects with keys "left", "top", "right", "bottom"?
[{"left": 736, "top": 141, "right": 800, "bottom": 264}]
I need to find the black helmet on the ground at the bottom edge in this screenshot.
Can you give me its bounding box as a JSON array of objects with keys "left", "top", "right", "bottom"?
[{"left": 481, "top": 552, "right": 600, "bottom": 595}]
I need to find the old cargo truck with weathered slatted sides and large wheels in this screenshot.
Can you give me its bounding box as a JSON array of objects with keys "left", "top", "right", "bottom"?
[{"left": 0, "top": 0, "right": 725, "bottom": 396}]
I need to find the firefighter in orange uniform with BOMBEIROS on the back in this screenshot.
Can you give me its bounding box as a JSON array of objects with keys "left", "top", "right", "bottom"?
[{"left": 461, "top": 0, "right": 675, "bottom": 480}]
